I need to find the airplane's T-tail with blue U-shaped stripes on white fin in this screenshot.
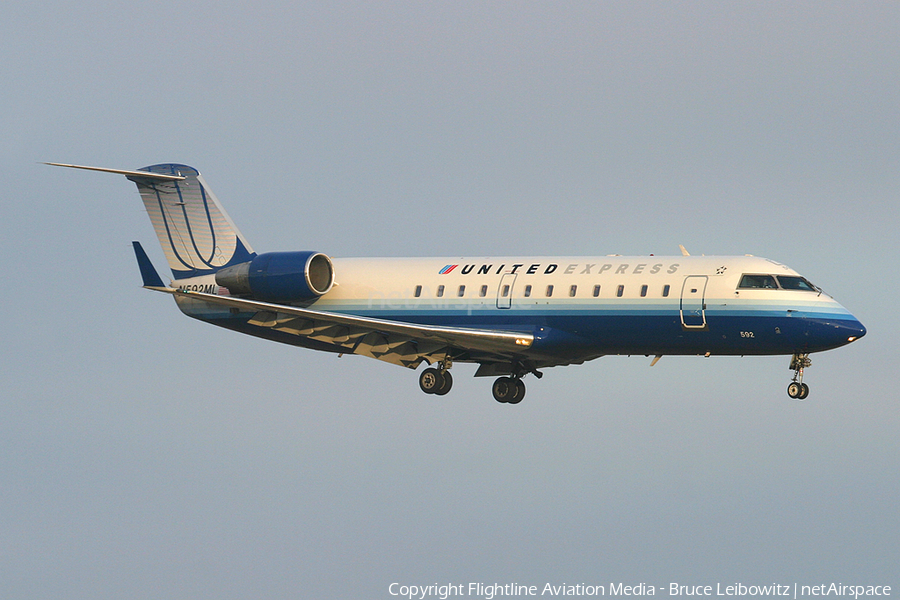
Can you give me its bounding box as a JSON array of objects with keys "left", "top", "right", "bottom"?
[{"left": 48, "top": 163, "right": 256, "bottom": 281}]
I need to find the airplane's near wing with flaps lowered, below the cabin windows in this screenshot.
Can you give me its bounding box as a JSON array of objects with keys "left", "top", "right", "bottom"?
[{"left": 165, "top": 287, "right": 534, "bottom": 369}]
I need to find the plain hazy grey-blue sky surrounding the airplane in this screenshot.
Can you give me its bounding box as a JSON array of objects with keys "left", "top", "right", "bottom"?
[{"left": 0, "top": 0, "right": 900, "bottom": 599}]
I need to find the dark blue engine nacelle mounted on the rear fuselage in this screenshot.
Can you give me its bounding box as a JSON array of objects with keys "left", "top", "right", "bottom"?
[{"left": 216, "top": 252, "right": 334, "bottom": 302}]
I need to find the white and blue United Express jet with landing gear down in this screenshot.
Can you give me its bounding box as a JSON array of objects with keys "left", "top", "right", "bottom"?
[{"left": 45, "top": 163, "right": 866, "bottom": 404}]
